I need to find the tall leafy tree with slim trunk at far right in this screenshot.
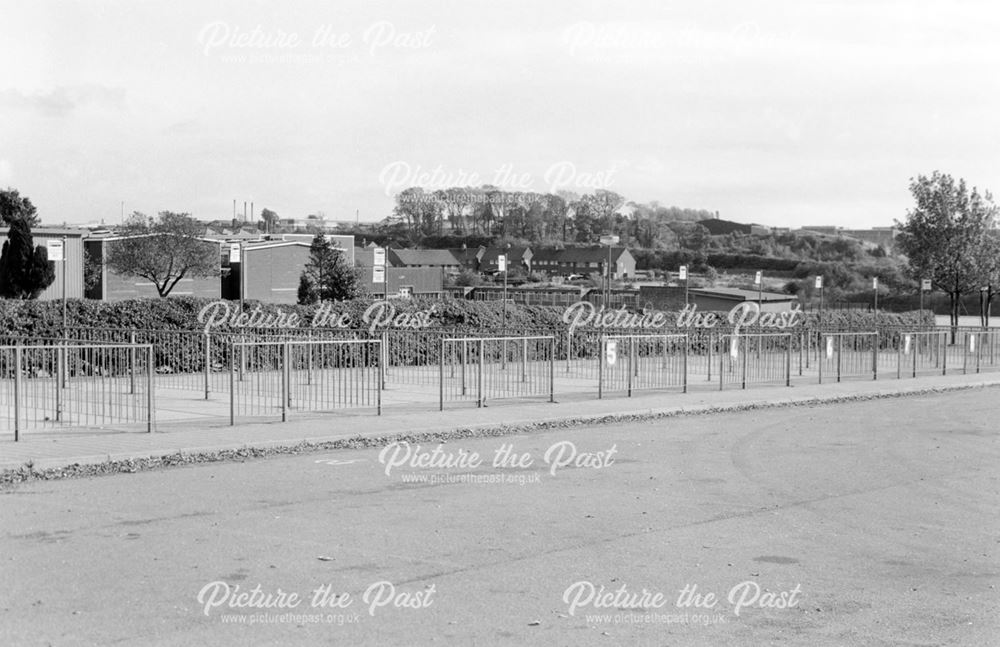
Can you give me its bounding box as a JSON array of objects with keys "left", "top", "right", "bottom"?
[{"left": 897, "top": 171, "right": 996, "bottom": 334}]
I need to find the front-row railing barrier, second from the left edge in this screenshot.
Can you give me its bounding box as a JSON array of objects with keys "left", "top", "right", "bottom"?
[{"left": 229, "top": 339, "right": 383, "bottom": 425}]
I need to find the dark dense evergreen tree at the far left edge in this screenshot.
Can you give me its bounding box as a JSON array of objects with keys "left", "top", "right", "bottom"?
[{"left": 0, "top": 216, "right": 56, "bottom": 299}]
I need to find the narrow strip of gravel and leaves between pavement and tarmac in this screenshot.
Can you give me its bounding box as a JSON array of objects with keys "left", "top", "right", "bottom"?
[{"left": 0, "top": 384, "right": 1000, "bottom": 488}]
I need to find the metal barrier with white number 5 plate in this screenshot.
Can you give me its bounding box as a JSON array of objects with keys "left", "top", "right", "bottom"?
[{"left": 597, "top": 335, "right": 688, "bottom": 398}]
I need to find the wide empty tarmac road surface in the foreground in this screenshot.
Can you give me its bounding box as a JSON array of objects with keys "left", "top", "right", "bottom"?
[{"left": 0, "top": 390, "right": 1000, "bottom": 646}]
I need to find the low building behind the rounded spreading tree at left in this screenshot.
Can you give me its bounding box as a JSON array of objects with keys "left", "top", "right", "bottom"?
[{"left": 83, "top": 234, "right": 222, "bottom": 301}]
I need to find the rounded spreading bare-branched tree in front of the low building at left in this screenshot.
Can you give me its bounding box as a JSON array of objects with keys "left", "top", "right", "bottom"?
[{"left": 107, "top": 211, "right": 220, "bottom": 297}]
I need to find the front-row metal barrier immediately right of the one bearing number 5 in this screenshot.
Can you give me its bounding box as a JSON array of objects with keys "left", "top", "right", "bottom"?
[{"left": 718, "top": 333, "right": 797, "bottom": 391}]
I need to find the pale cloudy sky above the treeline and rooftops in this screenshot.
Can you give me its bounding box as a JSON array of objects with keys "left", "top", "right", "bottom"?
[{"left": 0, "top": 0, "right": 1000, "bottom": 227}]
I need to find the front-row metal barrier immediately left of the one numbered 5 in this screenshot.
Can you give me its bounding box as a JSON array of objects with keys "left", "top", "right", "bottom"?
[{"left": 438, "top": 336, "right": 556, "bottom": 411}]
